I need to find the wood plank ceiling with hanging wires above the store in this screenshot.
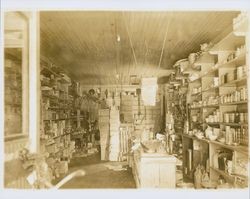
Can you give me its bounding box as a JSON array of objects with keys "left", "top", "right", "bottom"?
[{"left": 40, "top": 11, "right": 238, "bottom": 85}]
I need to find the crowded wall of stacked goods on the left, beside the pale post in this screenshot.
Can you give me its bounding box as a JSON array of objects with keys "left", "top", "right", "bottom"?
[{"left": 40, "top": 59, "right": 85, "bottom": 177}]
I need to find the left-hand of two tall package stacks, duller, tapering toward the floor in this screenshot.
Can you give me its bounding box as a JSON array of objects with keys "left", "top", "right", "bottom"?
[{"left": 98, "top": 109, "right": 109, "bottom": 160}]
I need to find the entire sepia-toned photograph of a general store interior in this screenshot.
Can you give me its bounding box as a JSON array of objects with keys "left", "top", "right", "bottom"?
[{"left": 1, "top": 0, "right": 250, "bottom": 197}]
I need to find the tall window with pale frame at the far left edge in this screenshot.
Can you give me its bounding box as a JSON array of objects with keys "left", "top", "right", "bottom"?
[{"left": 4, "top": 12, "right": 29, "bottom": 138}]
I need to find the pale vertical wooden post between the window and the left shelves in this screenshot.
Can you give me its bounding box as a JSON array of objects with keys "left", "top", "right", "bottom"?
[{"left": 29, "top": 11, "right": 40, "bottom": 152}]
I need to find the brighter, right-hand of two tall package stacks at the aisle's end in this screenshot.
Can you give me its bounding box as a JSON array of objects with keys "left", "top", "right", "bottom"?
[{"left": 109, "top": 106, "right": 120, "bottom": 161}]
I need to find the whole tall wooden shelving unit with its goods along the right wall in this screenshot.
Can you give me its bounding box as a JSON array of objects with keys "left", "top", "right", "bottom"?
[{"left": 183, "top": 13, "right": 249, "bottom": 187}]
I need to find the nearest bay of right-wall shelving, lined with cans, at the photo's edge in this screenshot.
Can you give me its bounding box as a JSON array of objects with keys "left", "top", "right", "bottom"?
[{"left": 210, "top": 25, "right": 249, "bottom": 187}]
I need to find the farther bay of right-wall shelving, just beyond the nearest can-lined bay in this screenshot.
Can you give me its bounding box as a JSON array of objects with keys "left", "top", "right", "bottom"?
[{"left": 183, "top": 52, "right": 217, "bottom": 180}]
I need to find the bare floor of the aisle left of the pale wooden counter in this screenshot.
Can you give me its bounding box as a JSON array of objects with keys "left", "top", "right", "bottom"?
[{"left": 53, "top": 154, "right": 136, "bottom": 189}]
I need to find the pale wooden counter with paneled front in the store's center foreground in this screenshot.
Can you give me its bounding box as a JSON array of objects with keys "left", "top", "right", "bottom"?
[{"left": 132, "top": 150, "right": 176, "bottom": 188}]
